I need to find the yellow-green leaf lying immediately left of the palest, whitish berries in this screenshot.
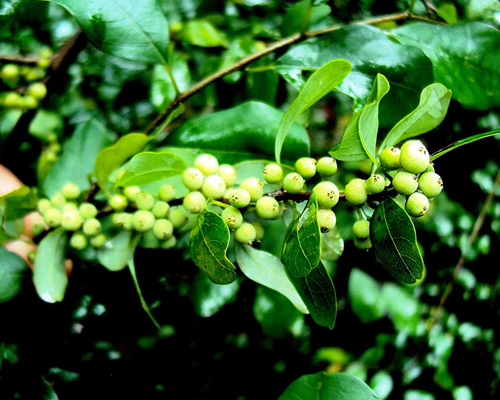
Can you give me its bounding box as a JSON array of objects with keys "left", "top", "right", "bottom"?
[{"left": 115, "top": 151, "right": 187, "bottom": 187}]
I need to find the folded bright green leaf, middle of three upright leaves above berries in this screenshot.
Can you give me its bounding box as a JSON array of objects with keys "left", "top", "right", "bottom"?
[{"left": 330, "top": 74, "right": 389, "bottom": 164}]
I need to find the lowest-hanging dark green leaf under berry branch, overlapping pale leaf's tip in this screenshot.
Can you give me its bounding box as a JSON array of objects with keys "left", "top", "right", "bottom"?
[{"left": 286, "top": 263, "right": 337, "bottom": 329}]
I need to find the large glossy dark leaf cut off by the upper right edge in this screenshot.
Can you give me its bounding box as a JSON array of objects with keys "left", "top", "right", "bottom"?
[{"left": 391, "top": 22, "right": 500, "bottom": 110}]
